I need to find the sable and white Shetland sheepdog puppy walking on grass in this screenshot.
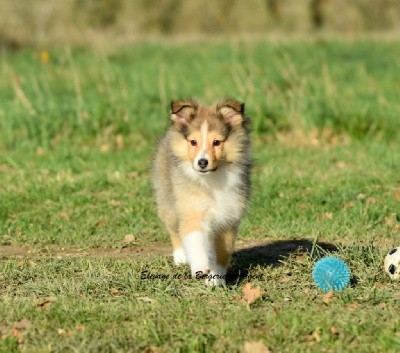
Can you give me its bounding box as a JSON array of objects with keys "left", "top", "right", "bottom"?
[{"left": 153, "top": 98, "right": 251, "bottom": 285}]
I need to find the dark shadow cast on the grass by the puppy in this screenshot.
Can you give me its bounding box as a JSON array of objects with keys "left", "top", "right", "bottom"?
[{"left": 226, "top": 239, "right": 339, "bottom": 285}]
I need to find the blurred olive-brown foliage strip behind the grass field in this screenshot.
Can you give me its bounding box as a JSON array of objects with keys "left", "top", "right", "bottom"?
[{"left": 0, "top": 0, "right": 400, "bottom": 48}]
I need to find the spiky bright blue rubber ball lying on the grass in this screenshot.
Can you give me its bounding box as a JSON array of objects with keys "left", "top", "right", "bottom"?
[{"left": 312, "top": 257, "right": 350, "bottom": 292}]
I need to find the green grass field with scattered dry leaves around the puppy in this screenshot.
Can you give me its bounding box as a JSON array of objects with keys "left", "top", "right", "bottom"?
[{"left": 0, "top": 41, "right": 400, "bottom": 353}]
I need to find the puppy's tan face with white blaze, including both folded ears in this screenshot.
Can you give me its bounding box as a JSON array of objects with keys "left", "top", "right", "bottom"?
[{"left": 171, "top": 99, "right": 245, "bottom": 175}]
